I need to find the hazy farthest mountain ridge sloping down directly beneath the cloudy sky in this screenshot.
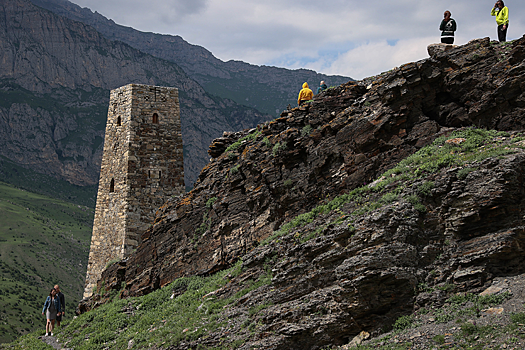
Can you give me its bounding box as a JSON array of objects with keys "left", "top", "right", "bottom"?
[{"left": 27, "top": 0, "right": 351, "bottom": 117}]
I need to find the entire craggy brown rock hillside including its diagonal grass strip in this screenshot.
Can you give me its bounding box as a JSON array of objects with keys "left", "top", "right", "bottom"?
[{"left": 77, "top": 37, "right": 525, "bottom": 349}]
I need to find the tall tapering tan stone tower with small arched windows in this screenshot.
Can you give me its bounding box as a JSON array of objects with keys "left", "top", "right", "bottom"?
[{"left": 84, "top": 84, "right": 184, "bottom": 297}]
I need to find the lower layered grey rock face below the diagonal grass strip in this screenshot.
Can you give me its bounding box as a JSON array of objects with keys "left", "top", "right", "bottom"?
[{"left": 189, "top": 148, "right": 525, "bottom": 349}]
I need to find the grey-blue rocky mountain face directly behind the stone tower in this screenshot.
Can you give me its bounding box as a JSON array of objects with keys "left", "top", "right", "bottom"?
[{"left": 0, "top": 0, "right": 268, "bottom": 185}]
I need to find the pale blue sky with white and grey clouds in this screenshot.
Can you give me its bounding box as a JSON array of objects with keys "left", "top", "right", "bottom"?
[{"left": 71, "top": 0, "right": 525, "bottom": 79}]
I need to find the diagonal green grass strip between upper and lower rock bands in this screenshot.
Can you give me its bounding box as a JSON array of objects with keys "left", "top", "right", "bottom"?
[{"left": 261, "top": 128, "right": 522, "bottom": 244}]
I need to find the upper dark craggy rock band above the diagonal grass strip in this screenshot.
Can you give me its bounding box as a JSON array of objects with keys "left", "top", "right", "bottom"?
[{"left": 113, "top": 34, "right": 524, "bottom": 294}]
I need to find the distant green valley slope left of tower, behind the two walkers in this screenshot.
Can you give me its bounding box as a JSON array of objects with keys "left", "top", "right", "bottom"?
[{"left": 0, "top": 182, "right": 93, "bottom": 342}]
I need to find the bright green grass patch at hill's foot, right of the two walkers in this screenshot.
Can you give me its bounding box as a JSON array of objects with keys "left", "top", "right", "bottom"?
[{"left": 29, "top": 261, "right": 272, "bottom": 350}]
